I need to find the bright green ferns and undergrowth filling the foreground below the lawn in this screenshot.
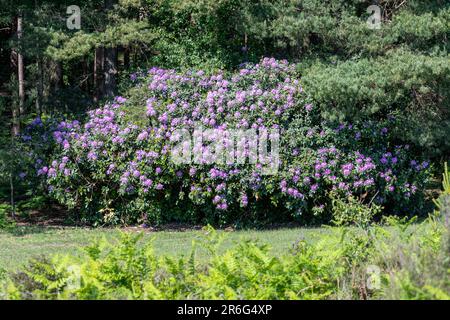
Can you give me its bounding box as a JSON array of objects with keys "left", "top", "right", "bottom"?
[{"left": 0, "top": 211, "right": 450, "bottom": 299}]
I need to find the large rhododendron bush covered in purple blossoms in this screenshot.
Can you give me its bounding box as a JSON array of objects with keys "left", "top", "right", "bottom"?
[{"left": 18, "top": 58, "right": 429, "bottom": 224}]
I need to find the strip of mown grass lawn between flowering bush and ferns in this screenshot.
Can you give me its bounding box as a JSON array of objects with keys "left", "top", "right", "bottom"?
[{"left": 0, "top": 227, "right": 330, "bottom": 271}]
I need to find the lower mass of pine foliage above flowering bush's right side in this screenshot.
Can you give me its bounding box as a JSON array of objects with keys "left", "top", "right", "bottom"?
[{"left": 303, "top": 50, "right": 450, "bottom": 157}]
